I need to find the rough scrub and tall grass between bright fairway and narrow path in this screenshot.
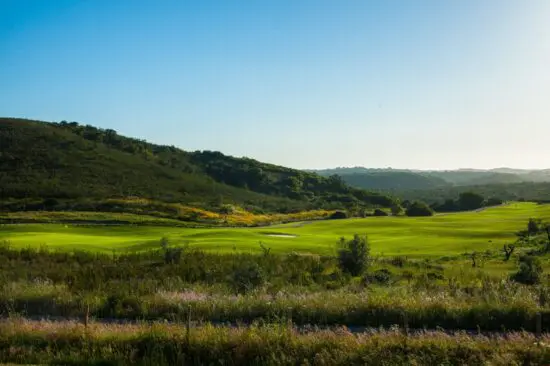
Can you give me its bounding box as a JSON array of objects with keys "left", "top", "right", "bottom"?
[{"left": 0, "top": 237, "right": 550, "bottom": 331}]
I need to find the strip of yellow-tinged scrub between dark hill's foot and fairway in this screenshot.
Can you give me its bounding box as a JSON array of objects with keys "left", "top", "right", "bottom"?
[{"left": 0, "top": 198, "right": 333, "bottom": 227}]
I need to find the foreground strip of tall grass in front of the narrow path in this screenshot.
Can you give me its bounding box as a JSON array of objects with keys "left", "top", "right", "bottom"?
[{"left": 0, "top": 320, "right": 550, "bottom": 365}]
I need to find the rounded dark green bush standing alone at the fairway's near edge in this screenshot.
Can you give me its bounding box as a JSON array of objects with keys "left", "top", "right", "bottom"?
[{"left": 338, "top": 234, "right": 370, "bottom": 276}]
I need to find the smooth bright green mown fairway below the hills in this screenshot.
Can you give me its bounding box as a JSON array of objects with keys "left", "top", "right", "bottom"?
[{"left": 0, "top": 203, "right": 550, "bottom": 257}]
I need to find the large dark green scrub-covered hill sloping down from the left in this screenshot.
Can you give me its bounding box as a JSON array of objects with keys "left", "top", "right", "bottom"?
[{"left": 0, "top": 118, "right": 394, "bottom": 212}]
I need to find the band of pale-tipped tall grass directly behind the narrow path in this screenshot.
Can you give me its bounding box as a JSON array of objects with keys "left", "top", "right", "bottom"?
[{"left": 0, "top": 284, "right": 550, "bottom": 332}]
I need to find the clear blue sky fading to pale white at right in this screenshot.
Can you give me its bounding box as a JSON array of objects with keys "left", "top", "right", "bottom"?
[{"left": 0, "top": 0, "right": 550, "bottom": 169}]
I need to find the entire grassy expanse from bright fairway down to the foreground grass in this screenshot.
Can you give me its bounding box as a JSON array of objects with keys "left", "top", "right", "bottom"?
[{"left": 0, "top": 202, "right": 550, "bottom": 365}]
